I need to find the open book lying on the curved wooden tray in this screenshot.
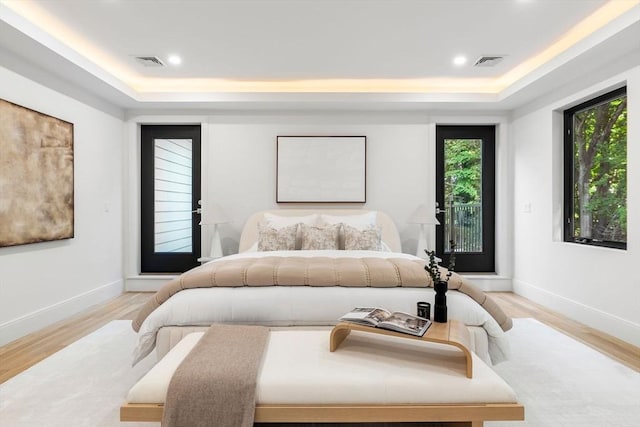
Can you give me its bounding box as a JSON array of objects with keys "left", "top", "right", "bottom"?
[{"left": 340, "top": 307, "right": 431, "bottom": 337}]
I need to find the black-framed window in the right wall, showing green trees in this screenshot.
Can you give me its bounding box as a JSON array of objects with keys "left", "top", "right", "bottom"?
[{"left": 564, "top": 87, "right": 627, "bottom": 249}]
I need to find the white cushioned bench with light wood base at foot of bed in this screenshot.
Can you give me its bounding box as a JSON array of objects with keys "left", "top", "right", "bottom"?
[{"left": 120, "top": 329, "right": 524, "bottom": 427}]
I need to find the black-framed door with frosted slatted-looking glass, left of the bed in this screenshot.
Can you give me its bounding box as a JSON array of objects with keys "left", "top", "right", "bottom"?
[{"left": 140, "top": 125, "right": 201, "bottom": 273}]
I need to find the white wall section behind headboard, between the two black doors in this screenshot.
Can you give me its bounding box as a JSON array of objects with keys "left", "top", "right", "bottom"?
[{"left": 208, "top": 116, "right": 435, "bottom": 252}]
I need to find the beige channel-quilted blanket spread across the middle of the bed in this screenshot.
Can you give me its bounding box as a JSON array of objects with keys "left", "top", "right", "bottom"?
[{"left": 132, "top": 257, "right": 512, "bottom": 332}]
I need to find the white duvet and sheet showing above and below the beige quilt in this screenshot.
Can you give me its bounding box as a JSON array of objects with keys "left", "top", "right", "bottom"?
[{"left": 134, "top": 250, "right": 509, "bottom": 364}]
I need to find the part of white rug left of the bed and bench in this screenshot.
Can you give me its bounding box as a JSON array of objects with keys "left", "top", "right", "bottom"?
[{"left": 0, "top": 320, "right": 160, "bottom": 427}]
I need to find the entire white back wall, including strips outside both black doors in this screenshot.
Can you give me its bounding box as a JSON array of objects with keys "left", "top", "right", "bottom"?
[{"left": 126, "top": 112, "right": 511, "bottom": 290}]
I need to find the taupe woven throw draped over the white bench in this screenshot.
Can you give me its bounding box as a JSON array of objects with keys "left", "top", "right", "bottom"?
[{"left": 162, "top": 325, "right": 269, "bottom": 427}]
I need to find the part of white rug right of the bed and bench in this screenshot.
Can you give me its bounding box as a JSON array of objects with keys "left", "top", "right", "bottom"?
[{"left": 485, "top": 319, "right": 640, "bottom": 427}]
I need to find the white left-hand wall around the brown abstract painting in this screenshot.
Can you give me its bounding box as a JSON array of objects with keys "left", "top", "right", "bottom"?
[{"left": 0, "top": 67, "right": 124, "bottom": 345}]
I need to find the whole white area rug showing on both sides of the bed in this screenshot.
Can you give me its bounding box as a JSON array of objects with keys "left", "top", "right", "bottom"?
[{"left": 0, "top": 319, "right": 640, "bottom": 427}]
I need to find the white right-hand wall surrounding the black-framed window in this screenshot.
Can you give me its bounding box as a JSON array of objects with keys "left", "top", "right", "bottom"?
[{"left": 510, "top": 67, "right": 640, "bottom": 345}]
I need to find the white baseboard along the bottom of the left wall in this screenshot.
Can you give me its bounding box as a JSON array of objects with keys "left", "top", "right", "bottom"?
[{"left": 0, "top": 280, "right": 123, "bottom": 345}]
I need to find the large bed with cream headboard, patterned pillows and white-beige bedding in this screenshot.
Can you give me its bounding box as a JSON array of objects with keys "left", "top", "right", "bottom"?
[{"left": 133, "top": 209, "right": 511, "bottom": 364}]
